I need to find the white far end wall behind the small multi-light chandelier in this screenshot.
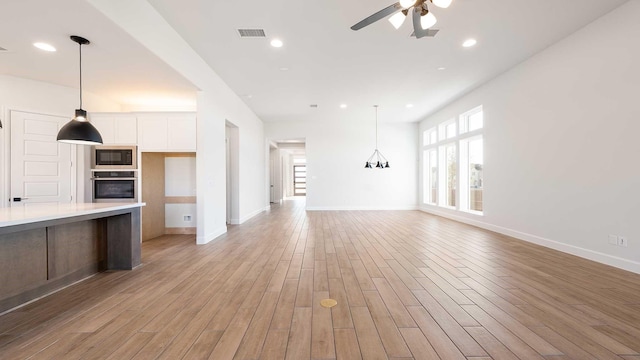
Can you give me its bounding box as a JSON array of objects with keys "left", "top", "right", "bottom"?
[{"left": 265, "top": 114, "right": 418, "bottom": 210}]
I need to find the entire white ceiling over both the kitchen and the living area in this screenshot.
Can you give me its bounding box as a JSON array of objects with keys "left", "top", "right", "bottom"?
[{"left": 0, "top": 0, "right": 627, "bottom": 121}]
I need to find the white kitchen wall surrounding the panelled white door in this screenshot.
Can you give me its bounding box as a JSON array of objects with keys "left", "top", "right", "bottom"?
[{"left": 0, "top": 75, "right": 120, "bottom": 207}]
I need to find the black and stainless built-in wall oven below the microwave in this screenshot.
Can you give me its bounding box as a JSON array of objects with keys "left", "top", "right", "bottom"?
[{"left": 91, "top": 169, "right": 138, "bottom": 203}]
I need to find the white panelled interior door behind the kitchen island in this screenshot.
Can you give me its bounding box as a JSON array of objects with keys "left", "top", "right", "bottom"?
[{"left": 10, "top": 111, "right": 76, "bottom": 206}]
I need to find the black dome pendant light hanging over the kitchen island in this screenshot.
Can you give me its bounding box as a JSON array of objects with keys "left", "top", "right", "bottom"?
[{"left": 57, "top": 35, "right": 102, "bottom": 145}]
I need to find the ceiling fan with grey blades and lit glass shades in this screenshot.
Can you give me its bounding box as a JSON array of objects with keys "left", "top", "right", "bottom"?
[{"left": 351, "top": 0, "right": 452, "bottom": 39}]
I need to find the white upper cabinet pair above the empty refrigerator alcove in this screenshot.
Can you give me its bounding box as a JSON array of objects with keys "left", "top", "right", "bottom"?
[{"left": 138, "top": 114, "right": 196, "bottom": 152}]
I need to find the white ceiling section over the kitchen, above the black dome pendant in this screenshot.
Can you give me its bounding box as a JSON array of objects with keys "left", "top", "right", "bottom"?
[{"left": 0, "top": 0, "right": 196, "bottom": 110}]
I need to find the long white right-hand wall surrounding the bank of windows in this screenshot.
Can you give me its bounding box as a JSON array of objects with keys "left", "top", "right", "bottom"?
[{"left": 420, "top": 0, "right": 640, "bottom": 272}]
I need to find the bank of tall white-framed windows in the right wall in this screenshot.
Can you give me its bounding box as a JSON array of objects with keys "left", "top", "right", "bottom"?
[{"left": 422, "top": 106, "right": 484, "bottom": 215}]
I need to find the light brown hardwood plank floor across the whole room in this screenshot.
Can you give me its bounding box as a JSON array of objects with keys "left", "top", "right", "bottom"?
[{"left": 0, "top": 201, "right": 640, "bottom": 360}]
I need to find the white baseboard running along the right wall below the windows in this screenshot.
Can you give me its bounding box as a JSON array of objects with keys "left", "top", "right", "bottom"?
[{"left": 420, "top": 207, "right": 640, "bottom": 274}]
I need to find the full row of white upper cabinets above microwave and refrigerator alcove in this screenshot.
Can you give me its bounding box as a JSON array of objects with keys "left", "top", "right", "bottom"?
[{"left": 90, "top": 113, "right": 196, "bottom": 152}]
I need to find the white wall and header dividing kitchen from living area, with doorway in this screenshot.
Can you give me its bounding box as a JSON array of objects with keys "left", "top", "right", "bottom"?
[{"left": 88, "top": 0, "right": 268, "bottom": 244}]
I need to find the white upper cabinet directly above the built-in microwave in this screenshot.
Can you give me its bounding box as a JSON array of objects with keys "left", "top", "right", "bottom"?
[{"left": 90, "top": 114, "right": 138, "bottom": 145}]
